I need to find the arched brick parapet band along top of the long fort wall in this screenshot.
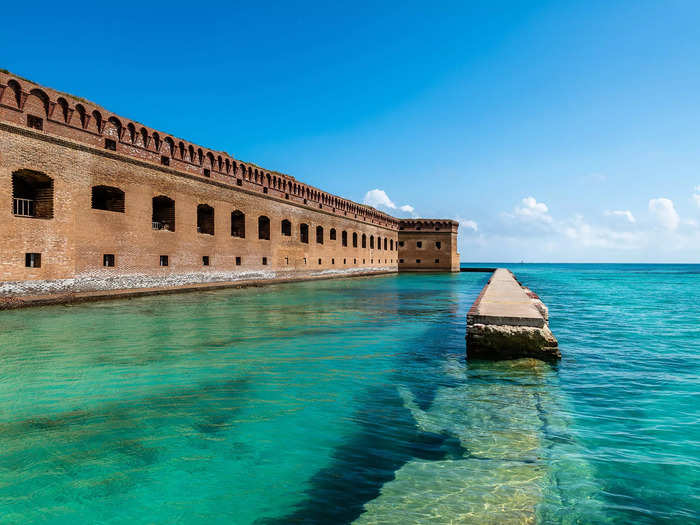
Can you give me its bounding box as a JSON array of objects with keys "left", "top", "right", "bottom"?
[{"left": 0, "top": 70, "right": 400, "bottom": 229}]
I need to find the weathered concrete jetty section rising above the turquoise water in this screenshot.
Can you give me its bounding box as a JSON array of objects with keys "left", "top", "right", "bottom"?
[{"left": 467, "top": 268, "right": 561, "bottom": 361}]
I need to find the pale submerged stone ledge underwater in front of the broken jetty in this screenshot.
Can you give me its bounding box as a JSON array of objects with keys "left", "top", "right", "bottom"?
[{"left": 356, "top": 359, "right": 603, "bottom": 524}]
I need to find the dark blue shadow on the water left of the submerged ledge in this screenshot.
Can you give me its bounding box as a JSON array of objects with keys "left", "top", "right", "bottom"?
[{"left": 256, "top": 310, "right": 465, "bottom": 525}]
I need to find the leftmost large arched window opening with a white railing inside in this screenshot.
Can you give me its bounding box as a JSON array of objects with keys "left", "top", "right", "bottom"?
[{"left": 12, "top": 170, "right": 53, "bottom": 219}]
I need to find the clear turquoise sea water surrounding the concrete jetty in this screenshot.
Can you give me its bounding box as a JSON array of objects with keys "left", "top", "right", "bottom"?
[{"left": 0, "top": 265, "right": 700, "bottom": 525}]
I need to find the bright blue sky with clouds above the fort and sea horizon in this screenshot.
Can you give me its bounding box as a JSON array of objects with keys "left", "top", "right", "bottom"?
[{"left": 0, "top": 0, "right": 700, "bottom": 262}]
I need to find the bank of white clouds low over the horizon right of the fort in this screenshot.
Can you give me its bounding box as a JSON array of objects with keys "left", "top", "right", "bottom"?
[{"left": 459, "top": 194, "right": 700, "bottom": 262}]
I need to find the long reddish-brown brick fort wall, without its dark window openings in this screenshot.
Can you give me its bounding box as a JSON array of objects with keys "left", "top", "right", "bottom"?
[{"left": 0, "top": 72, "right": 456, "bottom": 281}]
